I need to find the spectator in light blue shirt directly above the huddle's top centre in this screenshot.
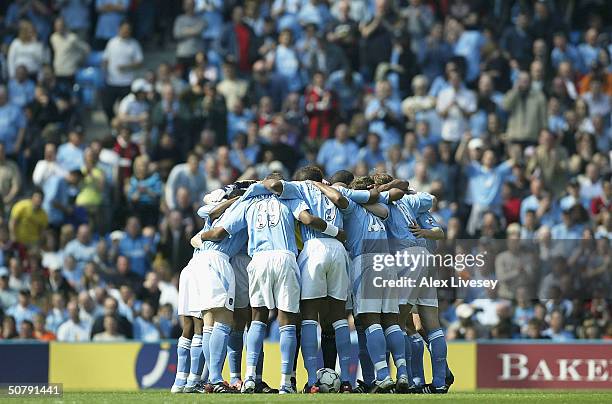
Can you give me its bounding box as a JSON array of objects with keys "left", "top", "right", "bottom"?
[{"left": 317, "top": 123, "right": 359, "bottom": 175}]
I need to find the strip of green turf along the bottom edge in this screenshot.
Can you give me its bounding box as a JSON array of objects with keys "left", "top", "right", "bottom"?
[{"left": 7, "top": 390, "right": 612, "bottom": 404}]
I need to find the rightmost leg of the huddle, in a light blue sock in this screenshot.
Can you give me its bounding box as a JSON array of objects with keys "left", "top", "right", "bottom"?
[{"left": 417, "top": 305, "right": 448, "bottom": 392}]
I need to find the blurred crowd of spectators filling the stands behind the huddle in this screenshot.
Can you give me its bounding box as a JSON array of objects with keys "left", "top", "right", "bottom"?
[{"left": 0, "top": 0, "right": 612, "bottom": 341}]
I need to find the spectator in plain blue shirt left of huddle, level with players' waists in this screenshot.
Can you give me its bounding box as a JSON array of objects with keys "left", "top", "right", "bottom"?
[{"left": 119, "top": 216, "right": 155, "bottom": 277}]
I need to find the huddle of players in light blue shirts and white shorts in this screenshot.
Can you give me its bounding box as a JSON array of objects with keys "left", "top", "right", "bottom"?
[{"left": 171, "top": 166, "right": 454, "bottom": 394}]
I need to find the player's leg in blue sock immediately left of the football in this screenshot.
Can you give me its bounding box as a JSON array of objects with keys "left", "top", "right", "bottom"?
[{"left": 298, "top": 296, "right": 325, "bottom": 393}]
